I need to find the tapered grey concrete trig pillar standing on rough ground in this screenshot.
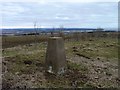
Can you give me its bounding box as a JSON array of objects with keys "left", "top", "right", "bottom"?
[{"left": 46, "top": 37, "right": 66, "bottom": 74}]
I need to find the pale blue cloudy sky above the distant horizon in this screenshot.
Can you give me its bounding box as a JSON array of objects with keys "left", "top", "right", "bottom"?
[{"left": 0, "top": 0, "right": 118, "bottom": 28}]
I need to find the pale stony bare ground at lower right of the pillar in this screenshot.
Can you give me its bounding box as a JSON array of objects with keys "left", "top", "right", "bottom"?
[{"left": 69, "top": 56, "right": 118, "bottom": 87}]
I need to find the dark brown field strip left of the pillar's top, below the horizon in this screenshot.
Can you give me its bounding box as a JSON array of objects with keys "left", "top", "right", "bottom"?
[{"left": 2, "top": 35, "right": 48, "bottom": 48}]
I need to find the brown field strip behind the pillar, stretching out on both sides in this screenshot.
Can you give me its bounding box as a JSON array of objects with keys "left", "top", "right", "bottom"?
[{"left": 2, "top": 32, "right": 117, "bottom": 48}]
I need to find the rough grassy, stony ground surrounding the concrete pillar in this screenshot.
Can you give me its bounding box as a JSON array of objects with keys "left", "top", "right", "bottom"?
[{"left": 3, "top": 32, "right": 120, "bottom": 88}]
